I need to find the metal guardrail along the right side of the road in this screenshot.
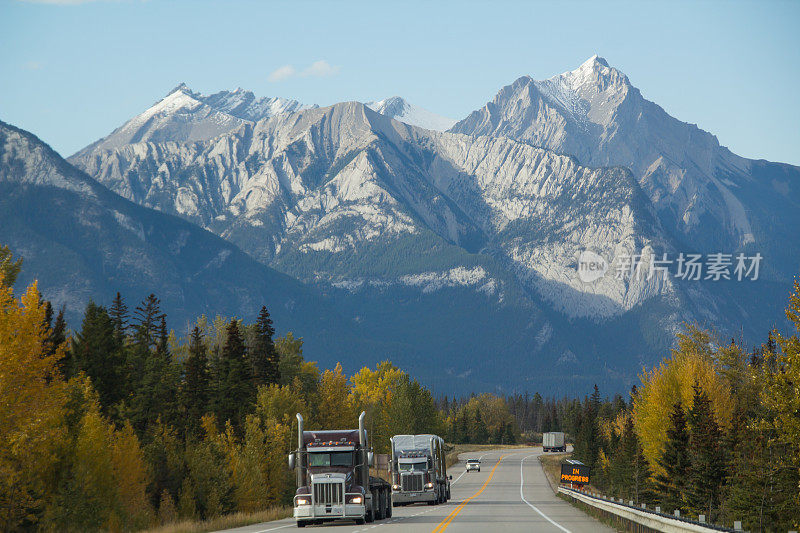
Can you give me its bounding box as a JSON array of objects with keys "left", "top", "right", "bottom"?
[{"left": 558, "top": 487, "right": 742, "bottom": 533}]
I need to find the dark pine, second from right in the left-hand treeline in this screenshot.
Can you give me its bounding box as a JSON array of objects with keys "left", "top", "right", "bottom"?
[{"left": 213, "top": 320, "right": 255, "bottom": 428}]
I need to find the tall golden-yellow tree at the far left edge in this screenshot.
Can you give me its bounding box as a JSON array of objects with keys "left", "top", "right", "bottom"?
[{"left": 0, "top": 283, "right": 66, "bottom": 531}]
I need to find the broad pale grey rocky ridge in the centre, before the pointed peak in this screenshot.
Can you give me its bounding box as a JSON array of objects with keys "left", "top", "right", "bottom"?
[{"left": 70, "top": 102, "right": 671, "bottom": 319}]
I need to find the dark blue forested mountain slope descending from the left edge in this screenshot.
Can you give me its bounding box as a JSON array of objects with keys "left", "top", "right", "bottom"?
[{"left": 0, "top": 121, "right": 320, "bottom": 327}]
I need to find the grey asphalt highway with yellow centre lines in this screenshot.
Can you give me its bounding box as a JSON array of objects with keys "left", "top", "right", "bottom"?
[{"left": 219, "top": 448, "right": 614, "bottom": 533}]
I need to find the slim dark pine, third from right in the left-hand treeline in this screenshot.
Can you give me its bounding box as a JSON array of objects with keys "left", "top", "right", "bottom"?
[{"left": 181, "top": 326, "right": 209, "bottom": 436}]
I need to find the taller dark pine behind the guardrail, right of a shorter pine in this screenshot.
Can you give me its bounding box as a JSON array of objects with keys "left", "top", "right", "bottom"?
[{"left": 687, "top": 382, "right": 725, "bottom": 519}]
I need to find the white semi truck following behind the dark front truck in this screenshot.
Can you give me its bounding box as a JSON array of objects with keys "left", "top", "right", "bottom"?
[{"left": 390, "top": 435, "right": 450, "bottom": 506}]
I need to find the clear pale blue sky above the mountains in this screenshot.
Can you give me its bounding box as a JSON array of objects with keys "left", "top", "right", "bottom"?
[{"left": 0, "top": 0, "right": 800, "bottom": 164}]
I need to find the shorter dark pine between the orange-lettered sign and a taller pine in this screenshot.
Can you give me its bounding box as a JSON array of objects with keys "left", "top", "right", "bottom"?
[{"left": 656, "top": 401, "right": 691, "bottom": 510}]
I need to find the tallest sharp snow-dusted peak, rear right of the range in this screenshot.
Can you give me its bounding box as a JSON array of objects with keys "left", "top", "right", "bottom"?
[{"left": 450, "top": 56, "right": 800, "bottom": 276}]
